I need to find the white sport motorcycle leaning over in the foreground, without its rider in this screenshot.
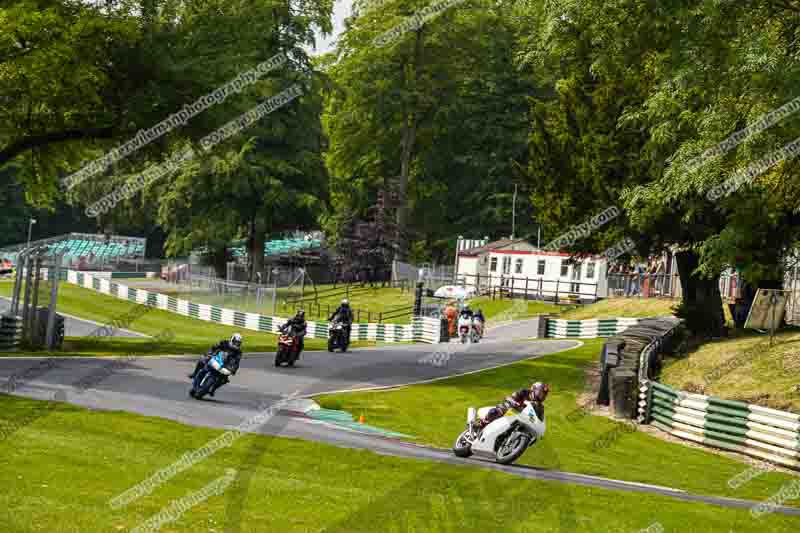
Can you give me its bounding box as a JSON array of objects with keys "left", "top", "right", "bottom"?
[{"left": 453, "top": 402, "right": 545, "bottom": 465}]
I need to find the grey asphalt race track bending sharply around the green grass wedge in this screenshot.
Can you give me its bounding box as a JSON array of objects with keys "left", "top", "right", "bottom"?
[{"left": 0, "top": 321, "right": 800, "bottom": 516}]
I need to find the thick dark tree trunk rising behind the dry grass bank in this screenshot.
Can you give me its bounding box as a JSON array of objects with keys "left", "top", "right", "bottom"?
[{"left": 675, "top": 251, "right": 725, "bottom": 337}]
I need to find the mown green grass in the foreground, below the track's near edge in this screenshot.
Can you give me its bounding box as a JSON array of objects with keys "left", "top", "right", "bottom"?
[{"left": 0, "top": 395, "right": 797, "bottom": 533}]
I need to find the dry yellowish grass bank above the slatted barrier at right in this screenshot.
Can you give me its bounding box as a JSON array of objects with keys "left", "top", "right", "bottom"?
[{"left": 662, "top": 329, "right": 800, "bottom": 413}]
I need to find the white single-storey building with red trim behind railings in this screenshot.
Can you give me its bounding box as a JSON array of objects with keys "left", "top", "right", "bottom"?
[{"left": 456, "top": 239, "right": 608, "bottom": 302}]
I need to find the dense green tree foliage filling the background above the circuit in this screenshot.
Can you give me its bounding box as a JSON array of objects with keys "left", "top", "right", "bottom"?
[{"left": 0, "top": 0, "right": 800, "bottom": 333}]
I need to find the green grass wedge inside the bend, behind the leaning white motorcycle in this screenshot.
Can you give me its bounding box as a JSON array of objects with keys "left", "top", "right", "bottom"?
[{"left": 317, "top": 339, "right": 798, "bottom": 504}]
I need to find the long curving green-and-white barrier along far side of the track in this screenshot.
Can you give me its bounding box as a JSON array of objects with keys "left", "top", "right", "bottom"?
[{"left": 67, "top": 270, "right": 441, "bottom": 344}]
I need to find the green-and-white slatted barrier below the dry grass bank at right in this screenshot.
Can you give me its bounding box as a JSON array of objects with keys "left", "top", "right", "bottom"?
[{"left": 639, "top": 381, "right": 800, "bottom": 470}]
